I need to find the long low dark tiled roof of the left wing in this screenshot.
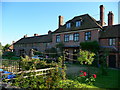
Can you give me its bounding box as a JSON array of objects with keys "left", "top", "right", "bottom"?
[{"left": 14, "top": 34, "right": 52, "bottom": 44}]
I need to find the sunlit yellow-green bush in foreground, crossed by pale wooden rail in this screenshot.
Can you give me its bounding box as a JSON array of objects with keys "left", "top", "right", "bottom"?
[{"left": 13, "top": 57, "right": 66, "bottom": 89}]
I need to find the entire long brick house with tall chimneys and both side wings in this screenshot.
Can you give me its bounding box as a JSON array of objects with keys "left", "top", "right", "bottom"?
[{"left": 14, "top": 5, "right": 120, "bottom": 67}]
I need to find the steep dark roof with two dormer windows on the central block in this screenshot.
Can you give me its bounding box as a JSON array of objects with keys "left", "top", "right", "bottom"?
[{"left": 53, "top": 14, "right": 102, "bottom": 33}]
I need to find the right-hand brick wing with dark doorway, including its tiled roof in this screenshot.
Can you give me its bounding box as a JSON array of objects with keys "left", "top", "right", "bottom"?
[{"left": 99, "top": 24, "right": 120, "bottom": 67}]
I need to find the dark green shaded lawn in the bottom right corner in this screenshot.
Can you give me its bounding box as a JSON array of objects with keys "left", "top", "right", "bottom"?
[{"left": 95, "top": 69, "right": 120, "bottom": 88}]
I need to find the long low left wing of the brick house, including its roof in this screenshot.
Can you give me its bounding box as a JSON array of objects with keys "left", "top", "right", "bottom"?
[{"left": 14, "top": 31, "right": 52, "bottom": 56}]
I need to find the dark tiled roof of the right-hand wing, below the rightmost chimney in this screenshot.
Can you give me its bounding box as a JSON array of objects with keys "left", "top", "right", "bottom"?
[{"left": 100, "top": 24, "right": 120, "bottom": 38}]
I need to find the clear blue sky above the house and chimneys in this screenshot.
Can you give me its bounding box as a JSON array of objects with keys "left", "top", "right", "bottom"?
[{"left": 2, "top": 2, "right": 118, "bottom": 45}]
